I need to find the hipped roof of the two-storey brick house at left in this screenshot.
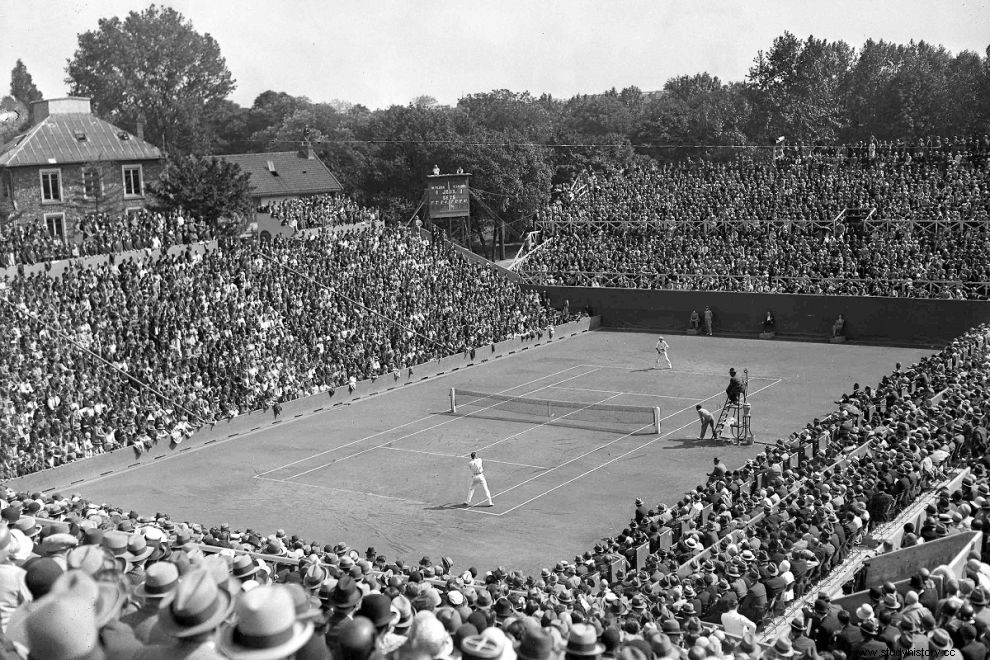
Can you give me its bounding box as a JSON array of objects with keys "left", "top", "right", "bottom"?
[{"left": 0, "top": 113, "right": 162, "bottom": 167}]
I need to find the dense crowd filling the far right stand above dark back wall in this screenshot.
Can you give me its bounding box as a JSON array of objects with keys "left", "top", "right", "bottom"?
[{"left": 523, "top": 140, "right": 990, "bottom": 299}]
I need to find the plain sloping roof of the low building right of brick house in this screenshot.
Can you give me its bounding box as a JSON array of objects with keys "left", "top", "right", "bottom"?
[{"left": 218, "top": 151, "right": 344, "bottom": 197}]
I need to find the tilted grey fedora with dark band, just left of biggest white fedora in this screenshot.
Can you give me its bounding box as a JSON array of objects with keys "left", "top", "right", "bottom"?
[{"left": 158, "top": 568, "right": 233, "bottom": 638}]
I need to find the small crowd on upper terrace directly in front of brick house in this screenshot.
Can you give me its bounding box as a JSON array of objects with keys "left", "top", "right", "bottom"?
[{"left": 0, "top": 210, "right": 214, "bottom": 267}]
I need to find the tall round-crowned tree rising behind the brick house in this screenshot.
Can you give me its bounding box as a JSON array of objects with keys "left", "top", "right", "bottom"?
[{"left": 66, "top": 5, "right": 234, "bottom": 153}]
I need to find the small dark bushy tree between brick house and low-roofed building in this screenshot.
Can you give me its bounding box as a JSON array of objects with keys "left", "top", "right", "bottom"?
[{"left": 151, "top": 154, "right": 252, "bottom": 229}]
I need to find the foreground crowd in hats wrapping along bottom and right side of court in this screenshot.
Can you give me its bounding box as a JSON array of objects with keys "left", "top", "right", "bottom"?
[{"left": 0, "top": 327, "right": 990, "bottom": 660}]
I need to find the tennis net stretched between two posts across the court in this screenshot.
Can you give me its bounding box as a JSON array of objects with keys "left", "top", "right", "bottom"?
[{"left": 450, "top": 387, "right": 660, "bottom": 434}]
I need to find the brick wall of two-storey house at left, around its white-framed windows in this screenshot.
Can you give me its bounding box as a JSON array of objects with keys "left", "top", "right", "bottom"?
[{"left": 0, "top": 161, "right": 162, "bottom": 240}]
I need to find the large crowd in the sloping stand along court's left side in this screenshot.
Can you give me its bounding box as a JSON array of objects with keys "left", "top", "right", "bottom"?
[{"left": 0, "top": 226, "right": 560, "bottom": 476}]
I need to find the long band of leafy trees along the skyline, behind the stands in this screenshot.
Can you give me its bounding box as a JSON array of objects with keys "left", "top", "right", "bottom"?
[{"left": 5, "top": 6, "right": 990, "bottom": 228}]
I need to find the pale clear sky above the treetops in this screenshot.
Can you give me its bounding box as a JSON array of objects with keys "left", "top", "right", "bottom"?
[{"left": 0, "top": 0, "right": 990, "bottom": 108}]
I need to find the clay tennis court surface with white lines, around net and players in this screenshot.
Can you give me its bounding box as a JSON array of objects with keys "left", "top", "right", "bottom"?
[{"left": 73, "top": 330, "right": 929, "bottom": 571}]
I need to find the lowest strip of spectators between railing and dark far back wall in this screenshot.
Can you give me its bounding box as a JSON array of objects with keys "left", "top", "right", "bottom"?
[{"left": 521, "top": 271, "right": 990, "bottom": 300}]
